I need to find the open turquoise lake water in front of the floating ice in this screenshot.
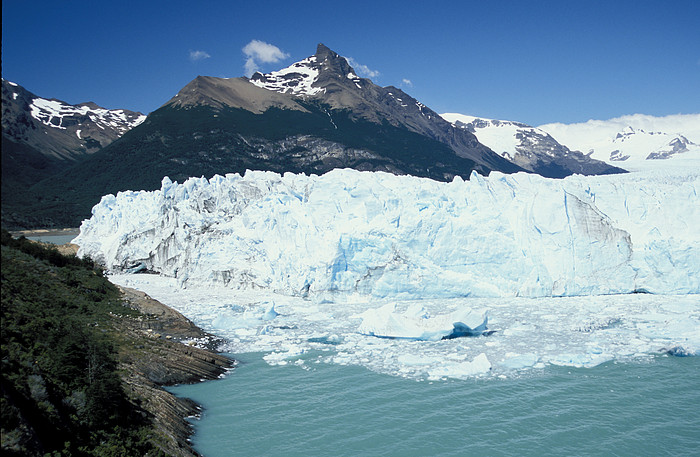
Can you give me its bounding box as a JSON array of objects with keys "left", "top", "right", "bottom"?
[{"left": 172, "top": 353, "right": 700, "bottom": 457}]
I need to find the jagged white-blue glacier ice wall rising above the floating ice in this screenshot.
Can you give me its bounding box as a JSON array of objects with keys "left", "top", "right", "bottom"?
[{"left": 74, "top": 169, "right": 700, "bottom": 298}]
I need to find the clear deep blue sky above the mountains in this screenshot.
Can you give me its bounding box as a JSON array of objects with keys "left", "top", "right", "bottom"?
[{"left": 2, "top": 0, "right": 700, "bottom": 125}]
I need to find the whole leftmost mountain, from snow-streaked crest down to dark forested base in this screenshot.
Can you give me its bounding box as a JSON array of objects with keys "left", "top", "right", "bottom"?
[{"left": 2, "top": 79, "right": 146, "bottom": 227}]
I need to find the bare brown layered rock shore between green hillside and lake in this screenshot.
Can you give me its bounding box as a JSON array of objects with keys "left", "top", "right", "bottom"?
[{"left": 114, "top": 287, "right": 234, "bottom": 457}]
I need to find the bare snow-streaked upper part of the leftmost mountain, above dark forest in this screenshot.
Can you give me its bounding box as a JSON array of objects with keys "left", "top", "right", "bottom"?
[{"left": 2, "top": 79, "right": 146, "bottom": 161}]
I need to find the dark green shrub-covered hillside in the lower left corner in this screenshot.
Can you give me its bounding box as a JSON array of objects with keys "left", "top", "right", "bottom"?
[{"left": 0, "top": 230, "right": 165, "bottom": 456}]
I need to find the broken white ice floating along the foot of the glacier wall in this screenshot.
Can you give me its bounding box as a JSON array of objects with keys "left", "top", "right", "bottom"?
[{"left": 110, "top": 274, "right": 700, "bottom": 379}]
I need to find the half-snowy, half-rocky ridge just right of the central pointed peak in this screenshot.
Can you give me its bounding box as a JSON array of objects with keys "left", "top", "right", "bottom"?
[{"left": 441, "top": 113, "right": 624, "bottom": 178}]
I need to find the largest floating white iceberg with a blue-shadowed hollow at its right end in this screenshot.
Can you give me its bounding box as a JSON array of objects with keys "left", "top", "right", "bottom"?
[{"left": 353, "top": 303, "right": 488, "bottom": 341}]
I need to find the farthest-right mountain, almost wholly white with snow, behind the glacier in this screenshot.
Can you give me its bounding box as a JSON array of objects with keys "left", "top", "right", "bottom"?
[{"left": 539, "top": 114, "right": 700, "bottom": 169}]
